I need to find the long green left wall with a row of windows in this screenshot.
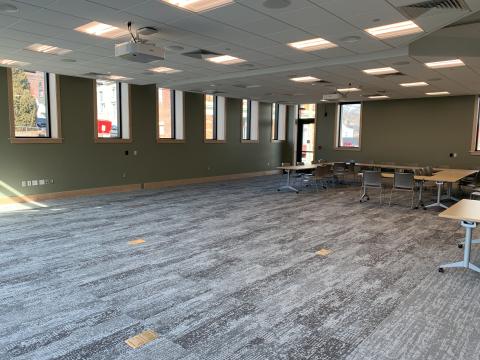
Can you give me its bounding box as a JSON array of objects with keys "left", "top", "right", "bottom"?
[{"left": 0, "top": 68, "right": 283, "bottom": 195}]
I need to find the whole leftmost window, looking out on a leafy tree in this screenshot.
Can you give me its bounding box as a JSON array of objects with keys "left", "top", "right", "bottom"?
[{"left": 7, "top": 68, "right": 61, "bottom": 142}]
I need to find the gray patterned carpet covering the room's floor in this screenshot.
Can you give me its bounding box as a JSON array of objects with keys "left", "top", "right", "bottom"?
[{"left": 0, "top": 176, "right": 480, "bottom": 360}]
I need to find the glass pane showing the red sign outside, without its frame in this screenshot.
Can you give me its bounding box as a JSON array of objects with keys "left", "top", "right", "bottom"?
[{"left": 97, "top": 80, "right": 121, "bottom": 138}]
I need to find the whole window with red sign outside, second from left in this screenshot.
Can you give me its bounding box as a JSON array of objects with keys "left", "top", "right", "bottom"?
[{"left": 94, "top": 80, "right": 131, "bottom": 143}]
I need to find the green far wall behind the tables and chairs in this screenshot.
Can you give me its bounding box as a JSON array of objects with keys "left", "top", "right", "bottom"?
[{"left": 284, "top": 96, "right": 480, "bottom": 168}]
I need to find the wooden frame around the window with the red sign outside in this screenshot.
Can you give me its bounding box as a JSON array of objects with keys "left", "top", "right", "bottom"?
[{"left": 93, "top": 79, "right": 133, "bottom": 144}]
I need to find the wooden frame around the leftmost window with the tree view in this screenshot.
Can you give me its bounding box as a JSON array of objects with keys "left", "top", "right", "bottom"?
[{"left": 6, "top": 68, "right": 63, "bottom": 144}]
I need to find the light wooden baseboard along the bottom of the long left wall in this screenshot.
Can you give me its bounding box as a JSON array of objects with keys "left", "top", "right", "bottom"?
[{"left": 0, "top": 170, "right": 280, "bottom": 205}]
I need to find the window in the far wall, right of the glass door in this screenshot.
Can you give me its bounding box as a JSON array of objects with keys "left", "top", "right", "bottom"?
[{"left": 335, "top": 103, "right": 362, "bottom": 149}]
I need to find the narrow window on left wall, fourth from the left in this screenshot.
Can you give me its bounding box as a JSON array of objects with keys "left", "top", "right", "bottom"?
[{"left": 205, "top": 95, "right": 225, "bottom": 142}]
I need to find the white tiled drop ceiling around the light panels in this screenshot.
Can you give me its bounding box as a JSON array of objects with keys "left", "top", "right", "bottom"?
[{"left": 0, "top": 0, "right": 480, "bottom": 103}]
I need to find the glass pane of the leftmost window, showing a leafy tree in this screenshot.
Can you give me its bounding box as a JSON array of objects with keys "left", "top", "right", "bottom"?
[{"left": 12, "top": 69, "right": 50, "bottom": 138}]
